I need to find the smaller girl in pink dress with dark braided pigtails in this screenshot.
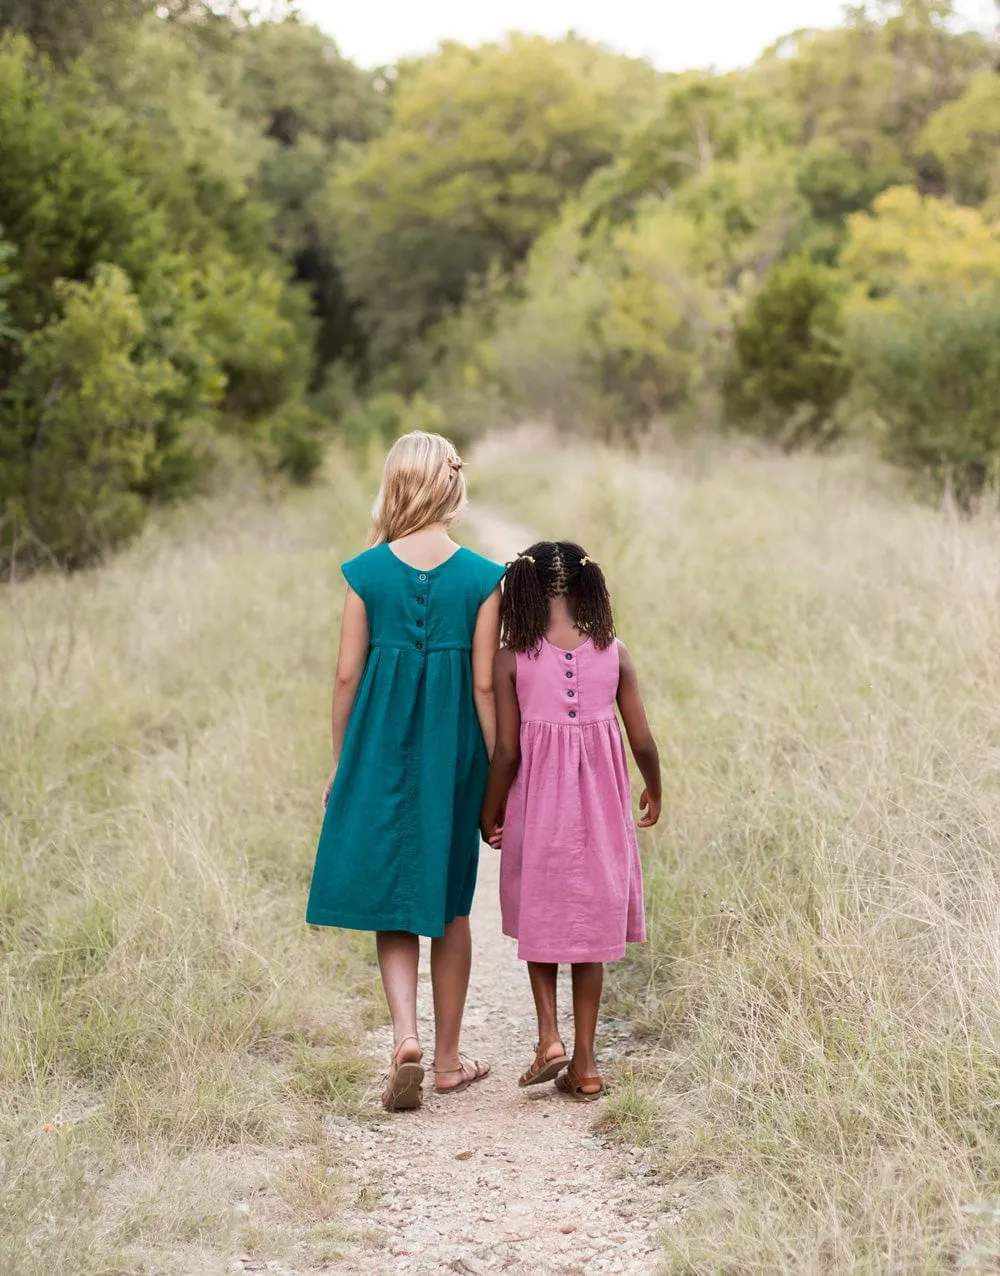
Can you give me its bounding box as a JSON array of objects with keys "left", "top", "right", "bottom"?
[{"left": 482, "top": 541, "right": 661, "bottom": 1100}]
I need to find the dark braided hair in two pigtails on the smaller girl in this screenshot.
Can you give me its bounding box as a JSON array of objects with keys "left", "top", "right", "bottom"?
[{"left": 500, "top": 541, "right": 615, "bottom": 652}]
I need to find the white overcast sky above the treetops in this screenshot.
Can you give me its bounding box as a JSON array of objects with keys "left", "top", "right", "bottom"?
[{"left": 298, "top": 0, "right": 996, "bottom": 70}]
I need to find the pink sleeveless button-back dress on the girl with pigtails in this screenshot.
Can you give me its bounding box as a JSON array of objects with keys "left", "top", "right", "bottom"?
[{"left": 500, "top": 641, "right": 645, "bottom": 962}]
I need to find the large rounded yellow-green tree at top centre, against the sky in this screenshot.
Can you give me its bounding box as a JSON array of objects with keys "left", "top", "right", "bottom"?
[{"left": 325, "top": 36, "right": 652, "bottom": 367}]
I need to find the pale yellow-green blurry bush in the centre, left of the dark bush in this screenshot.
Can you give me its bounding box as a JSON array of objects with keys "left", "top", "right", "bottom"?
[{"left": 480, "top": 202, "right": 724, "bottom": 429}]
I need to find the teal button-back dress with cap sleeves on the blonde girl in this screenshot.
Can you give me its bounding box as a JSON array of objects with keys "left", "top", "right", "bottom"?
[{"left": 306, "top": 545, "right": 504, "bottom": 937}]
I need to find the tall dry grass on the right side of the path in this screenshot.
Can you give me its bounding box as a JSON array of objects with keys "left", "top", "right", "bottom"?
[{"left": 476, "top": 434, "right": 1000, "bottom": 1276}]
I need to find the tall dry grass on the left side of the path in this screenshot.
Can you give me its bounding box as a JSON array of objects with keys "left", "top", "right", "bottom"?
[{"left": 0, "top": 464, "right": 382, "bottom": 1276}]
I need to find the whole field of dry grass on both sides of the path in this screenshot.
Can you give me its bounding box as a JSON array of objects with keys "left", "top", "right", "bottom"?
[{"left": 0, "top": 431, "right": 1000, "bottom": 1276}]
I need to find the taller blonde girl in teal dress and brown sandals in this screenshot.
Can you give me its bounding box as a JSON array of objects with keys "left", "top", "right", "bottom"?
[{"left": 306, "top": 431, "right": 504, "bottom": 1111}]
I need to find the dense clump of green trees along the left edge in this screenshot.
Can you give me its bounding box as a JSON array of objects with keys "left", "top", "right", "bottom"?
[{"left": 0, "top": 19, "right": 319, "bottom": 564}]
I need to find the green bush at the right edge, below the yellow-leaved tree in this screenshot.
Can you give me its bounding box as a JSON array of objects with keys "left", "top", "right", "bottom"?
[{"left": 848, "top": 288, "right": 1000, "bottom": 504}]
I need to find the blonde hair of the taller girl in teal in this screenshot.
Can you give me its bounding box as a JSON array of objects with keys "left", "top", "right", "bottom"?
[{"left": 369, "top": 430, "right": 466, "bottom": 546}]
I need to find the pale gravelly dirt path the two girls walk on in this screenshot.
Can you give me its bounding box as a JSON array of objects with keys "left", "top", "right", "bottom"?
[{"left": 334, "top": 509, "right": 668, "bottom": 1276}]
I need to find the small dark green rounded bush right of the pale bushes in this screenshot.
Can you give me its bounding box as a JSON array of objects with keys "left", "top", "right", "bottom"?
[{"left": 724, "top": 258, "right": 849, "bottom": 447}]
